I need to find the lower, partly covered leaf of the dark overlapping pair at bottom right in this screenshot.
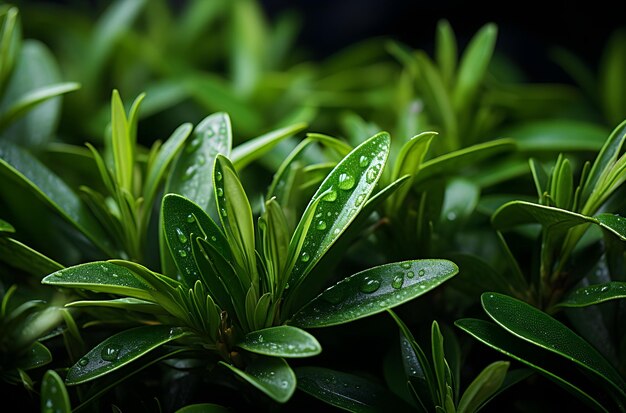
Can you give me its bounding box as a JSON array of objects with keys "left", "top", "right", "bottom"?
[{"left": 454, "top": 318, "right": 608, "bottom": 413}]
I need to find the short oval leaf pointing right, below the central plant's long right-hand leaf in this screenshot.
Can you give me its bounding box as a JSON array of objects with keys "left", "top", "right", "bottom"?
[{"left": 237, "top": 326, "right": 322, "bottom": 357}]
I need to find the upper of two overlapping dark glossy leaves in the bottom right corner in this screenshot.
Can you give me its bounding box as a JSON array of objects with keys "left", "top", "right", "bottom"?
[{"left": 481, "top": 293, "right": 626, "bottom": 396}]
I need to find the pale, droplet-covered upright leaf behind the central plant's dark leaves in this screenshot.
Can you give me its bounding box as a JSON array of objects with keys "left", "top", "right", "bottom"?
[{"left": 165, "top": 113, "right": 232, "bottom": 212}]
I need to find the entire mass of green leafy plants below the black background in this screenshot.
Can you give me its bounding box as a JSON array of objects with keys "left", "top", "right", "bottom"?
[{"left": 0, "top": 0, "right": 626, "bottom": 413}]
